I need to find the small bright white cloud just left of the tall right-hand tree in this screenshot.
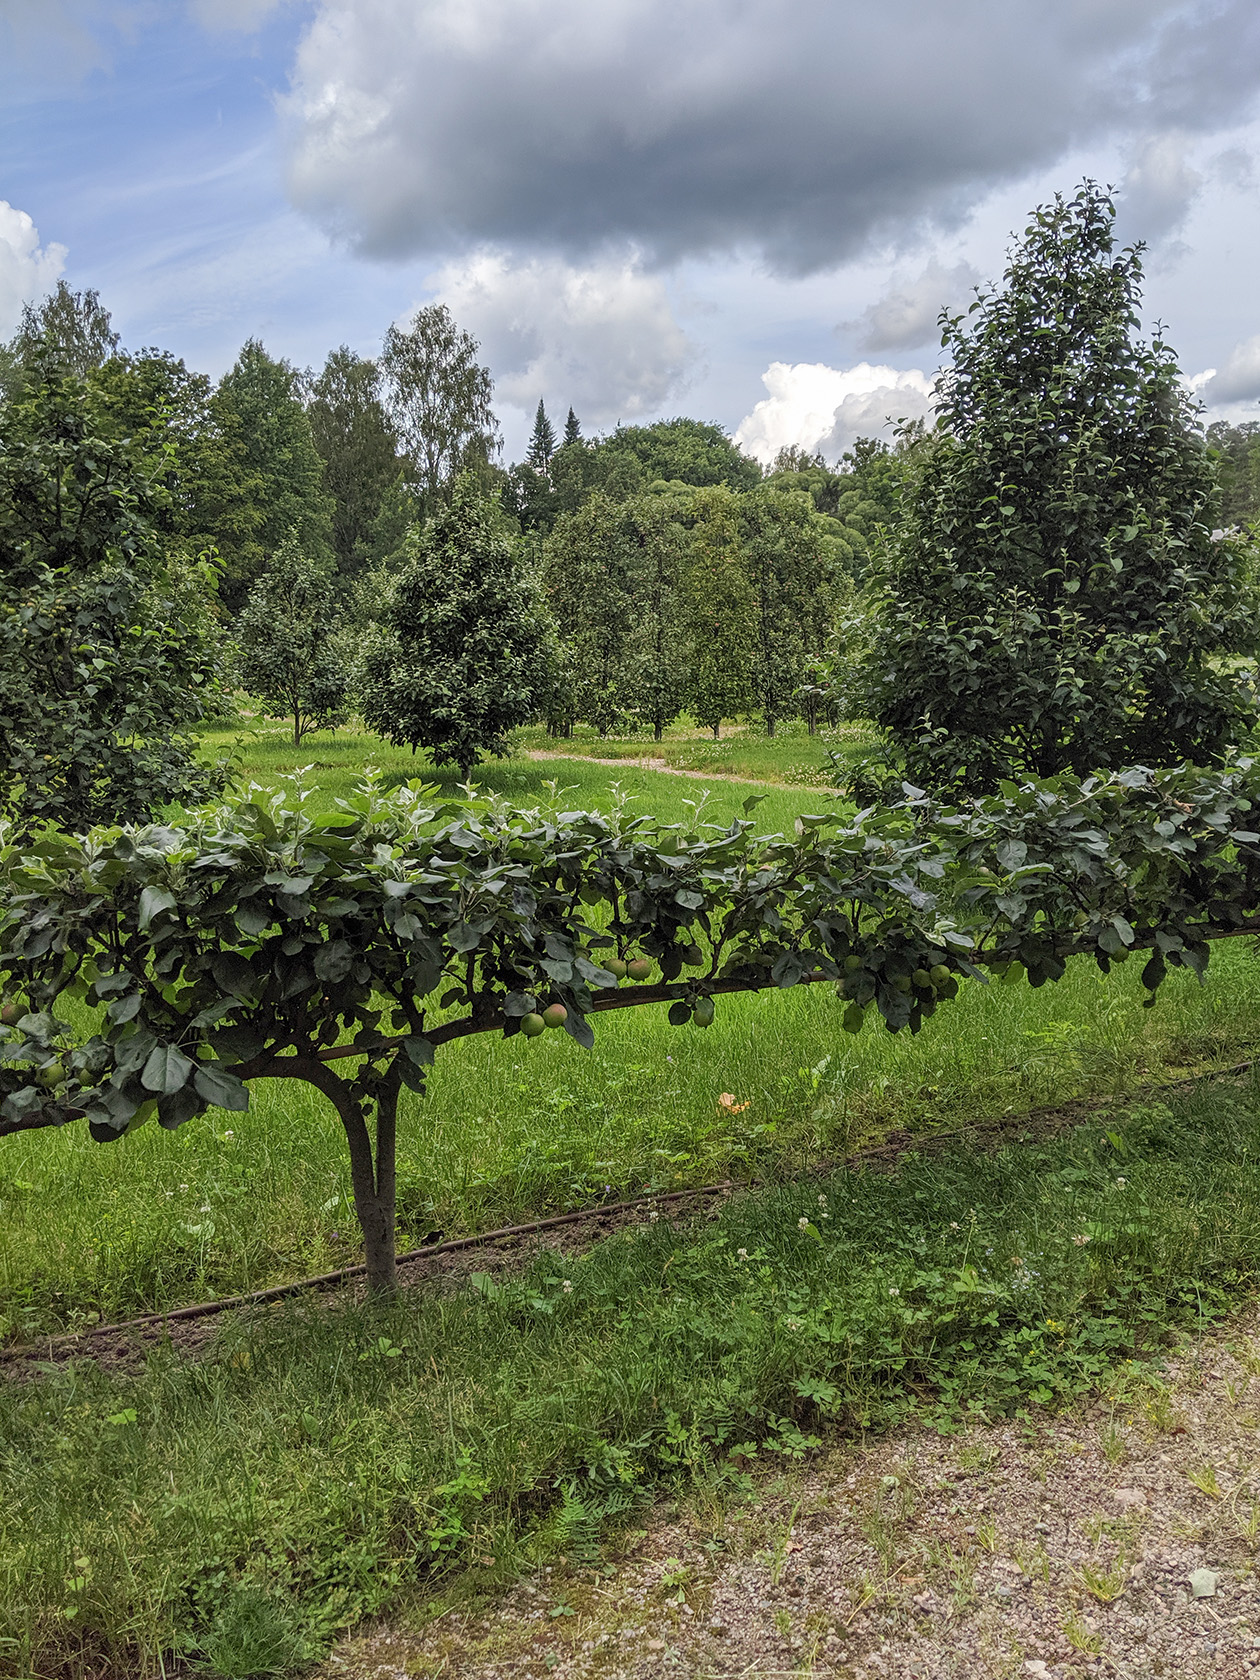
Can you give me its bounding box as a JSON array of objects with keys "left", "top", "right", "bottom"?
[{"left": 736, "top": 361, "right": 934, "bottom": 462}]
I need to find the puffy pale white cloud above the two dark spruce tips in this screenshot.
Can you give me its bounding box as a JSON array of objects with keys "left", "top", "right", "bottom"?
[{"left": 435, "top": 250, "right": 694, "bottom": 432}]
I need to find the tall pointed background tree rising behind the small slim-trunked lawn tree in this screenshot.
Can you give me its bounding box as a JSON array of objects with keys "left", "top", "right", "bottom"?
[{"left": 213, "top": 339, "right": 341, "bottom": 608}]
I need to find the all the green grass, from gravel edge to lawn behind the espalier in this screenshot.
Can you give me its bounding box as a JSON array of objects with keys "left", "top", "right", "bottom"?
[{"left": 0, "top": 726, "right": 1260, "bottom": 1680}]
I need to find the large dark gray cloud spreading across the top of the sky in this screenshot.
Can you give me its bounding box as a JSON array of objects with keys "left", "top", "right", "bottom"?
[{"left": 286, "top": 0, "right": 1260, "bottom": 274}]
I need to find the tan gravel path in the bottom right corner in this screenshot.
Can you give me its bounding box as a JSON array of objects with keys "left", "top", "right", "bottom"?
[{"left": 319, "top": 1309, "right": 1260, "bottom": 1680}]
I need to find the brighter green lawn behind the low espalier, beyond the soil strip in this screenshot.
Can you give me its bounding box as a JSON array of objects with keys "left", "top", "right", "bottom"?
[{"left": 0, "top": 702, "right": 1260, "bottom": 1336}]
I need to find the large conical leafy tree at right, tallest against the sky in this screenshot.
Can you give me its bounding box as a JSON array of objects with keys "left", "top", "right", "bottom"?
[{"left": 862, "top": 183, "right": 1255, "bottom": 788}]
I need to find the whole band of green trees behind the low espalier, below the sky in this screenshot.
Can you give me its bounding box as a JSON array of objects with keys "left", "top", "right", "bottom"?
[{"left": 0, "top": 183, "right": 1260, "bottom": 836}]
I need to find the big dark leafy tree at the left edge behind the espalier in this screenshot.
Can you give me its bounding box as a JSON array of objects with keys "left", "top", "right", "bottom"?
[{"left": 0, "top": 357, "right": 215, "bottom": 828}]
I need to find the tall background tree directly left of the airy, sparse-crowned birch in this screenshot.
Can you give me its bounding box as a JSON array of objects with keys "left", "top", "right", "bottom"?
[{"left": 307, "top": 344, "right": 402, "bottom": 575}]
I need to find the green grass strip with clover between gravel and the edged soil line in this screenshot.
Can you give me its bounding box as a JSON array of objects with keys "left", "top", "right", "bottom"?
[{"left": 0, "top": 1087, "right": 1260, "bottom": 1680}]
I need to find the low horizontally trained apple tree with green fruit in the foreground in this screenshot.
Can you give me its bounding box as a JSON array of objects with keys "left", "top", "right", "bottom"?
[{"left": 0, "top": 764, "right": 1260, "bottom": 1290}]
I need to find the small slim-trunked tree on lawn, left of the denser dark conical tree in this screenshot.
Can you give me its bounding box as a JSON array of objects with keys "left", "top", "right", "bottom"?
[{"left": 237, "top": 528, "right": 349, "bottom": 746}]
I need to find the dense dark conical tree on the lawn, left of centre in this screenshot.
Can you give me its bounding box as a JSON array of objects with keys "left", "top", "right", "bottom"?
[{"left": 361, "top": 474, "right": 548, "bottom": 780}]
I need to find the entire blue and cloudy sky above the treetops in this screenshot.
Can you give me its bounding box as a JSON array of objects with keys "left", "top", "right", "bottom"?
[{"left": 0, "top": 0, "right": 1260, "bottom": 459}]
